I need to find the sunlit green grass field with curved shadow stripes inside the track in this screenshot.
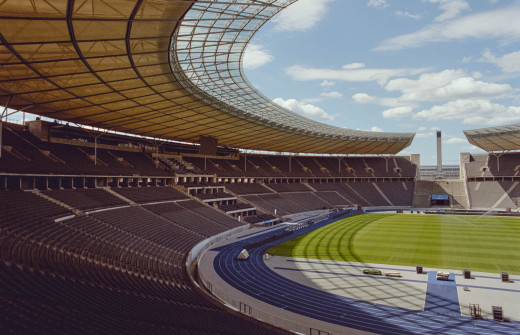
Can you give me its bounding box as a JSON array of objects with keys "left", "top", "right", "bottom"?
[{"left": 267, "top": 214, "right": 520, "bottom": 274}]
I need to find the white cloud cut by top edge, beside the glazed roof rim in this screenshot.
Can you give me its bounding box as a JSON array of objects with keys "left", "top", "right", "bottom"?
[{"left": 271, "top": 0, "right": 334, "bottom": 31}]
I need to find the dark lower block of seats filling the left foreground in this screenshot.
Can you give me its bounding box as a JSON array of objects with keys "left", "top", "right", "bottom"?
[{"left": 0, "top": 190, "right": 275, "bottom": 335}]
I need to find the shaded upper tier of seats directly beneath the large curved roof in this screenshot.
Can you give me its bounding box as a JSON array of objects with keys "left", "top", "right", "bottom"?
[{"left": 0, "top": 127, "right": 416, "bottom": 181}]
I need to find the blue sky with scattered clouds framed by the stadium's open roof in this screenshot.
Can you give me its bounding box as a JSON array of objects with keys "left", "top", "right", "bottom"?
[{"left": 244, "top": 0, "right": 520, "bottom": 165}]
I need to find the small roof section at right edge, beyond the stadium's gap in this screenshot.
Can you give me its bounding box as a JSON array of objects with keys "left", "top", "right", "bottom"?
[{"left": 464, "top": 123, "right": 520, "bottom": 151}]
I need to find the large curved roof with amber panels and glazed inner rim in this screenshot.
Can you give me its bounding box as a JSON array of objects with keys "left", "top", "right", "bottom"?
[{"left": 0, "top": 0, "right": 414, "bottom": 154}]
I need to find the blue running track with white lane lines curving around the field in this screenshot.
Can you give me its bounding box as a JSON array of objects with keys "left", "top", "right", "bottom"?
[{"left": 213, "top": 211, "right": 520, "bottom": 334}]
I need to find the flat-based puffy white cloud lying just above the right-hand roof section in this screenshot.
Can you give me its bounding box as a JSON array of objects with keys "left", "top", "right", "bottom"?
[{"left": 414, "top": 99, "right": 520, "bottom": 125}]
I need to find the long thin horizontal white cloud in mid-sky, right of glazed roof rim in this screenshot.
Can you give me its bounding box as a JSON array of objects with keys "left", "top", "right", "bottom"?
[{"left": 285, "top": 65, "right": 427, "bottom": 85}]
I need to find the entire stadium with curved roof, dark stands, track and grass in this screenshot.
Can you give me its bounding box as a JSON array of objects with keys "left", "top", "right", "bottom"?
[{"left": 0, "top": 0, "right": 520, "bottom": 335}]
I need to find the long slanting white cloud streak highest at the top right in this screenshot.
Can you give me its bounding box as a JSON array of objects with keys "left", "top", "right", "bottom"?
[{"left": 375, "top": 4, "right": 520, "bottom": 51}]
